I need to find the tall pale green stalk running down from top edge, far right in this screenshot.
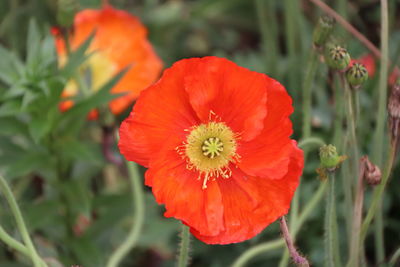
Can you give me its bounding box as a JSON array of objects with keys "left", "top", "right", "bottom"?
[{"left": 372, "top": 0, "right": 389, "bottom": 263}]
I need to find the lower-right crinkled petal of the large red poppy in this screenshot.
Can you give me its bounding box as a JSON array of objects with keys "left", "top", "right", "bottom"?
[{"left": 191, "top": 142, "right": 304, "bottom": 244}]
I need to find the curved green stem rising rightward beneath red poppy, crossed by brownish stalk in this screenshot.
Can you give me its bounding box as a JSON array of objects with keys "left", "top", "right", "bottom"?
[{"left": 232, "top": 182, "right": 327, "bottom": 267}]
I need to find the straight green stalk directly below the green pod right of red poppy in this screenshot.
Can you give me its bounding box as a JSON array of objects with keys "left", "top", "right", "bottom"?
[{"left": 325, "top": 172, "right": 341, "bottom": 267}]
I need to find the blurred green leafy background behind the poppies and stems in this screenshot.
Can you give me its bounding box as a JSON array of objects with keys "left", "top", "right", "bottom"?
[{"left": 0, "top": 0, "right": 400, "bottom": 267}]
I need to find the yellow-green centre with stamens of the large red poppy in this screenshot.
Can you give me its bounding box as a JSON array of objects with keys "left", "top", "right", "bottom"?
[{"left": 176, "top": 121, "right": 239, "bottom": 189}]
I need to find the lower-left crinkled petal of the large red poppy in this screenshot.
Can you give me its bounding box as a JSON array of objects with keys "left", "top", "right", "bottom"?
[{"left": 146, "top": 145, "right": 224, "bottom": 238}]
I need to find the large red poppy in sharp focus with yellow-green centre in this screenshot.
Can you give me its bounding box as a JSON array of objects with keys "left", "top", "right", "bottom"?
[{"left": 118, "top": 57, "right": 303, "bottom": 244}]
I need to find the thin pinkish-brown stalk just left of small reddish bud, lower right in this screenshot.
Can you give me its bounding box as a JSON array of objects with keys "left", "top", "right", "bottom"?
[{"left": 347, "top": 158, "right": 365, "bottom": 267}]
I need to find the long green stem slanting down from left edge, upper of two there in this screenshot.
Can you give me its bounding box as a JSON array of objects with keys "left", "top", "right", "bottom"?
[{"left": 0, "top": 175, "right": 46, "bottom": 267}]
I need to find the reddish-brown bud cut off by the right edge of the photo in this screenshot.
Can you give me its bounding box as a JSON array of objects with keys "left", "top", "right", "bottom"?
[{"left": 388, "top": 82, "right": 400, "bottom": 142}]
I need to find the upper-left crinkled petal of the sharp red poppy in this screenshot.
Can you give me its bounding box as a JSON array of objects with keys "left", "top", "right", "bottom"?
[{"left": 118, "top": 63, "right": 199, "bottom": 167}]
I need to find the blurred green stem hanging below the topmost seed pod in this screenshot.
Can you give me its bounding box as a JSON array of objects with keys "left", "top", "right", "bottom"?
[{"left": 302, "top": 49, "right": 318, "bottom": 139}]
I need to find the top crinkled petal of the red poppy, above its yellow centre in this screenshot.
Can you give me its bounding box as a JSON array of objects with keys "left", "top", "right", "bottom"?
[{"left": 179, "top": 57, "right": 270, "bottom": 140}]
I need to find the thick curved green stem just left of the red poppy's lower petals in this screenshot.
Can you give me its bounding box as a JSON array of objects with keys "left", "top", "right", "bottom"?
[{"left": 106, "top": 162, "right": 144, "bottom": 267}]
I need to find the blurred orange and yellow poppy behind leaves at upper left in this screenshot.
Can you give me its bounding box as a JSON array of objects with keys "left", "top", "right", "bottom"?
[{"left": 53, "top": 5, "right": 162, "bottom": 114}]
